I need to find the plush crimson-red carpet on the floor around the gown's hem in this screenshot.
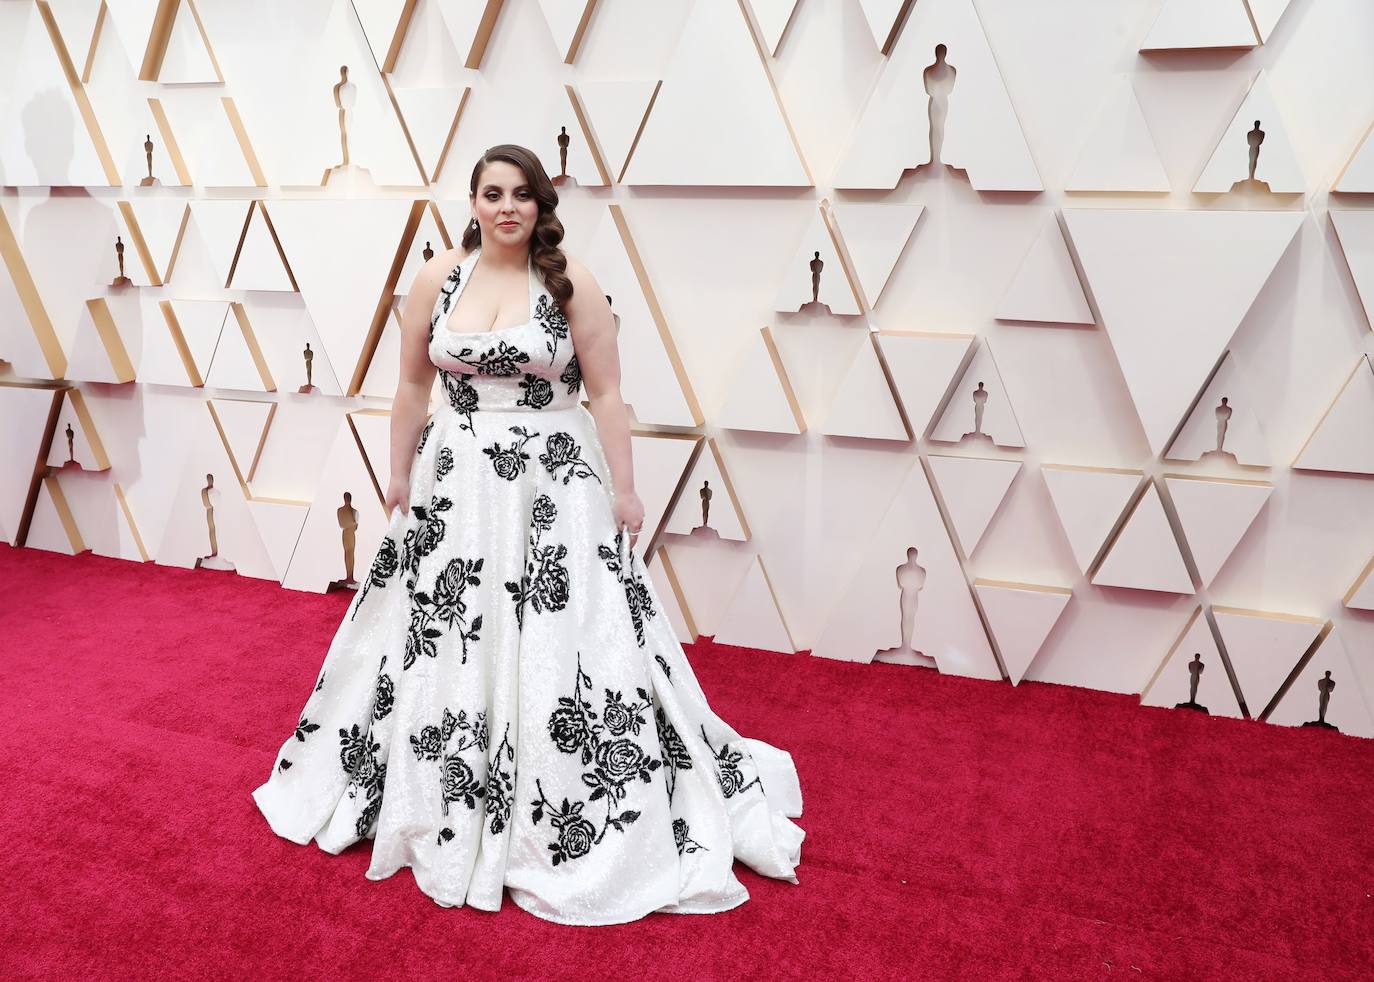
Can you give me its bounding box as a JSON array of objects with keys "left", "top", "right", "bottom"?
[{"left": 0, "top": 545, "right": 1374, "bottom": 981}]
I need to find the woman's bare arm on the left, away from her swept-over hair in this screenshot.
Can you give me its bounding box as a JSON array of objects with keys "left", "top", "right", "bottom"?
[{"left": 385, "top": 250, "right": 462, "bottom": 516}]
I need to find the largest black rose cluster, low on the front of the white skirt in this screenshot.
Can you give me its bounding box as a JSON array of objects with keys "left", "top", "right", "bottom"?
[{"left": 530, "top": 652, "right": 662, "bottom": 867}]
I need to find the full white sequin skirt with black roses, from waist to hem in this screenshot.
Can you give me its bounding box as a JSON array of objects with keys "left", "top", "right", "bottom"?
[{"left": 253, "top": 405, "right": 805, "bottom": 924}]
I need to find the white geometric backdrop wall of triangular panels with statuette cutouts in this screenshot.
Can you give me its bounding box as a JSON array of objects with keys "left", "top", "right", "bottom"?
[{"left": 0, "top": 0, "right": 1374, "bottom": 736}]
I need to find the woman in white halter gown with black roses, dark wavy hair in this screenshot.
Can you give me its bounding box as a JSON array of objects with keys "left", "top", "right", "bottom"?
[{"left": 253, "top": 144, "right": 804, "bottom": 924}]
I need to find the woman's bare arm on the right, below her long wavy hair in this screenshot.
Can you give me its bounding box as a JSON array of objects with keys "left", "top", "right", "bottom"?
[{"left": 563, "top": 257, "right": 644, "bottom": 532}]
